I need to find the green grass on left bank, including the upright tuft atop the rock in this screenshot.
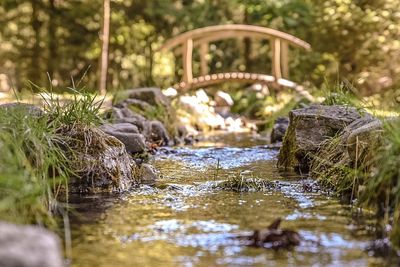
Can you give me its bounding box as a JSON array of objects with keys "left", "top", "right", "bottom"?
[{"left": 0, "top": 85, "right": 102, "bottom": 227}]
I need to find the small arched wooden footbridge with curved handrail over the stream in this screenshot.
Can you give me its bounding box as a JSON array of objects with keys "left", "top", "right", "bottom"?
[{"left": 161, "top": 24, "right": 311, "bottom": 97}]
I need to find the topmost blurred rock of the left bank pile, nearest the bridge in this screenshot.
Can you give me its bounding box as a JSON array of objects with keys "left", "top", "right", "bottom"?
[{"left": 127, "top": 88, "right": 170, "bottom": 109}]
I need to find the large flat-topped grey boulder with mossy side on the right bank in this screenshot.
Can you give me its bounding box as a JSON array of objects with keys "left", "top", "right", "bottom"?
[{"left": 278, "top": 105, "right": 362, "bottom": 170}]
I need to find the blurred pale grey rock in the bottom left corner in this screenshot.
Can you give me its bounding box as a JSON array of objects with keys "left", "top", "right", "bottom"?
[{"left": 0, "top": 222, "right": 64, "bottom": 267}]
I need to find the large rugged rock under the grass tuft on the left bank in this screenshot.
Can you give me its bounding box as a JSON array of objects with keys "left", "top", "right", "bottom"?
[{"left": 60, "top": 125, "right": 136, "bottom": 193}]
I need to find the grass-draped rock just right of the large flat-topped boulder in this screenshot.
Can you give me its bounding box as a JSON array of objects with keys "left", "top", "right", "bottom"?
[{"left": 310, "top": 114, "right": 383, "bottom": 192}]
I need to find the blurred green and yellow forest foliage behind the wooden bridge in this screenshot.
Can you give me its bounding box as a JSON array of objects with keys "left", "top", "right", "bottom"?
[{"left": 0, "top": 0, "right": 400, "bottom": 93}]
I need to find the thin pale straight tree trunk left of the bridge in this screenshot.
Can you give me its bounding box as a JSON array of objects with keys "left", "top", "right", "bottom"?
[{"left": 99, "top": 0, "right": 111, "bottom": 95}]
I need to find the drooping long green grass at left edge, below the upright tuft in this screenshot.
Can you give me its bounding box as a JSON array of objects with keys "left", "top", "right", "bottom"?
[{"left": 0, "top": 105, "right": 71, "bottom": 226}]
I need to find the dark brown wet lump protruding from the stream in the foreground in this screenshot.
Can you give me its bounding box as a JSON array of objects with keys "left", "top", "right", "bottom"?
[{"left": 249, "top": 218, "right": 301, "bottom": 249}]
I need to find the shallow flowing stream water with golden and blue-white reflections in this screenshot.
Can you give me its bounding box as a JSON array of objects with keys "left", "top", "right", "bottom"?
[{"left": 72, "top": 135, "right": 382, "bottom": 267}]
